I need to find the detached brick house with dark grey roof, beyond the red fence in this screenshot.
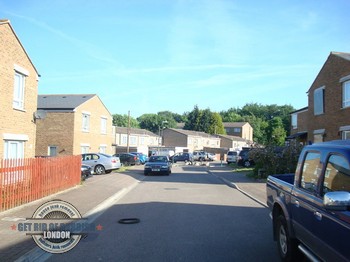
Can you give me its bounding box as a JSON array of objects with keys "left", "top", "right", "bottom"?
[{"left": 36, "top": 94, "right": 114, "bottom": 156}]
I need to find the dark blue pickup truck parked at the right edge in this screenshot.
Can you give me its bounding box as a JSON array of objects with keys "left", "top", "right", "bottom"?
[{"left": 266, "top": 140, "right": 350, "bottom": 261}]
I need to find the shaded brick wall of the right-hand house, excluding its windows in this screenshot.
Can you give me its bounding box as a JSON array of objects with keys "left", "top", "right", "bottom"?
[{"left": 307, "top": 54, "right": 350, "bottom": 141}]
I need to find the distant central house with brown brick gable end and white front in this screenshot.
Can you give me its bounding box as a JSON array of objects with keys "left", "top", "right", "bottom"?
[{"left": 162, "top": 128, "right": 220, "bottom": 152}]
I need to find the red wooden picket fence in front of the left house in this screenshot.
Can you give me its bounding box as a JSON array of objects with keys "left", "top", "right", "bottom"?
[{"left": 0, "top": 156, "right": 81, "bottom": 211}]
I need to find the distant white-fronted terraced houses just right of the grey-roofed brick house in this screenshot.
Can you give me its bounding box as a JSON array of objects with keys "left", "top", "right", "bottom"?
[{"left": 114, "top": 127, "right": 161, "bottom": 155}]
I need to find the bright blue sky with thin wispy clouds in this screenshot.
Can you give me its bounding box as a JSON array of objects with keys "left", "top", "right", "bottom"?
[{"left": 0, "top": 0, "right": 350, "bottom": 117}]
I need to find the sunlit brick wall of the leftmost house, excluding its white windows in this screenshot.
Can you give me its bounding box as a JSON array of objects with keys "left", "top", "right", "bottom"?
[{"left": 0, "top": 21, "right": 38, "bottom": 158}]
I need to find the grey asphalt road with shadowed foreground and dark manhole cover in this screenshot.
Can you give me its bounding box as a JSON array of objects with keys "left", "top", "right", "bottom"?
[{"left": 45, "top": 166, "right": 279, "bottom": 262}]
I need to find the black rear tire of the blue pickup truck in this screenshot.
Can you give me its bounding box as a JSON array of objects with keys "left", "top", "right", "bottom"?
[{"left": 276, "top": 215, "right": 300, "bottom": 261}]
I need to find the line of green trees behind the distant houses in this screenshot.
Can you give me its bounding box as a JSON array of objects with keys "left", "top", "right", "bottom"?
[{"left": 113, "top": 103, "right": 295, "bottom": 145}]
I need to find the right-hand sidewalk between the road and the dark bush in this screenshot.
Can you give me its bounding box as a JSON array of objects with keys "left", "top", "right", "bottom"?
[{"left": 208, "top": 164, "right": 267, "bottom": 207}]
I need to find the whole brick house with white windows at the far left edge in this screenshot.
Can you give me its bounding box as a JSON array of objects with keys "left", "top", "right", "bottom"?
[{"left": 0, "top": 20, "right": 40, "bottom": 158}]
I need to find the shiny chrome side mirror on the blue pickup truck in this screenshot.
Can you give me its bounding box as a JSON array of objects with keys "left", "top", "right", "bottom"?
[{"left": 323, "top": 191, "right": 350, "bottom": 211}]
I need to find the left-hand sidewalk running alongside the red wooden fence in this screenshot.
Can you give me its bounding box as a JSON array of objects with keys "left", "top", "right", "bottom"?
[{"left": 0, "top": 168, "right": 144, "bottom": 261}]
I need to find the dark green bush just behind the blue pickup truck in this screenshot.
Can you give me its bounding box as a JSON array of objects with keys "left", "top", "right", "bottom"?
[{"left": 249, "top": 144, "right": 302, "bottom": 178}]
